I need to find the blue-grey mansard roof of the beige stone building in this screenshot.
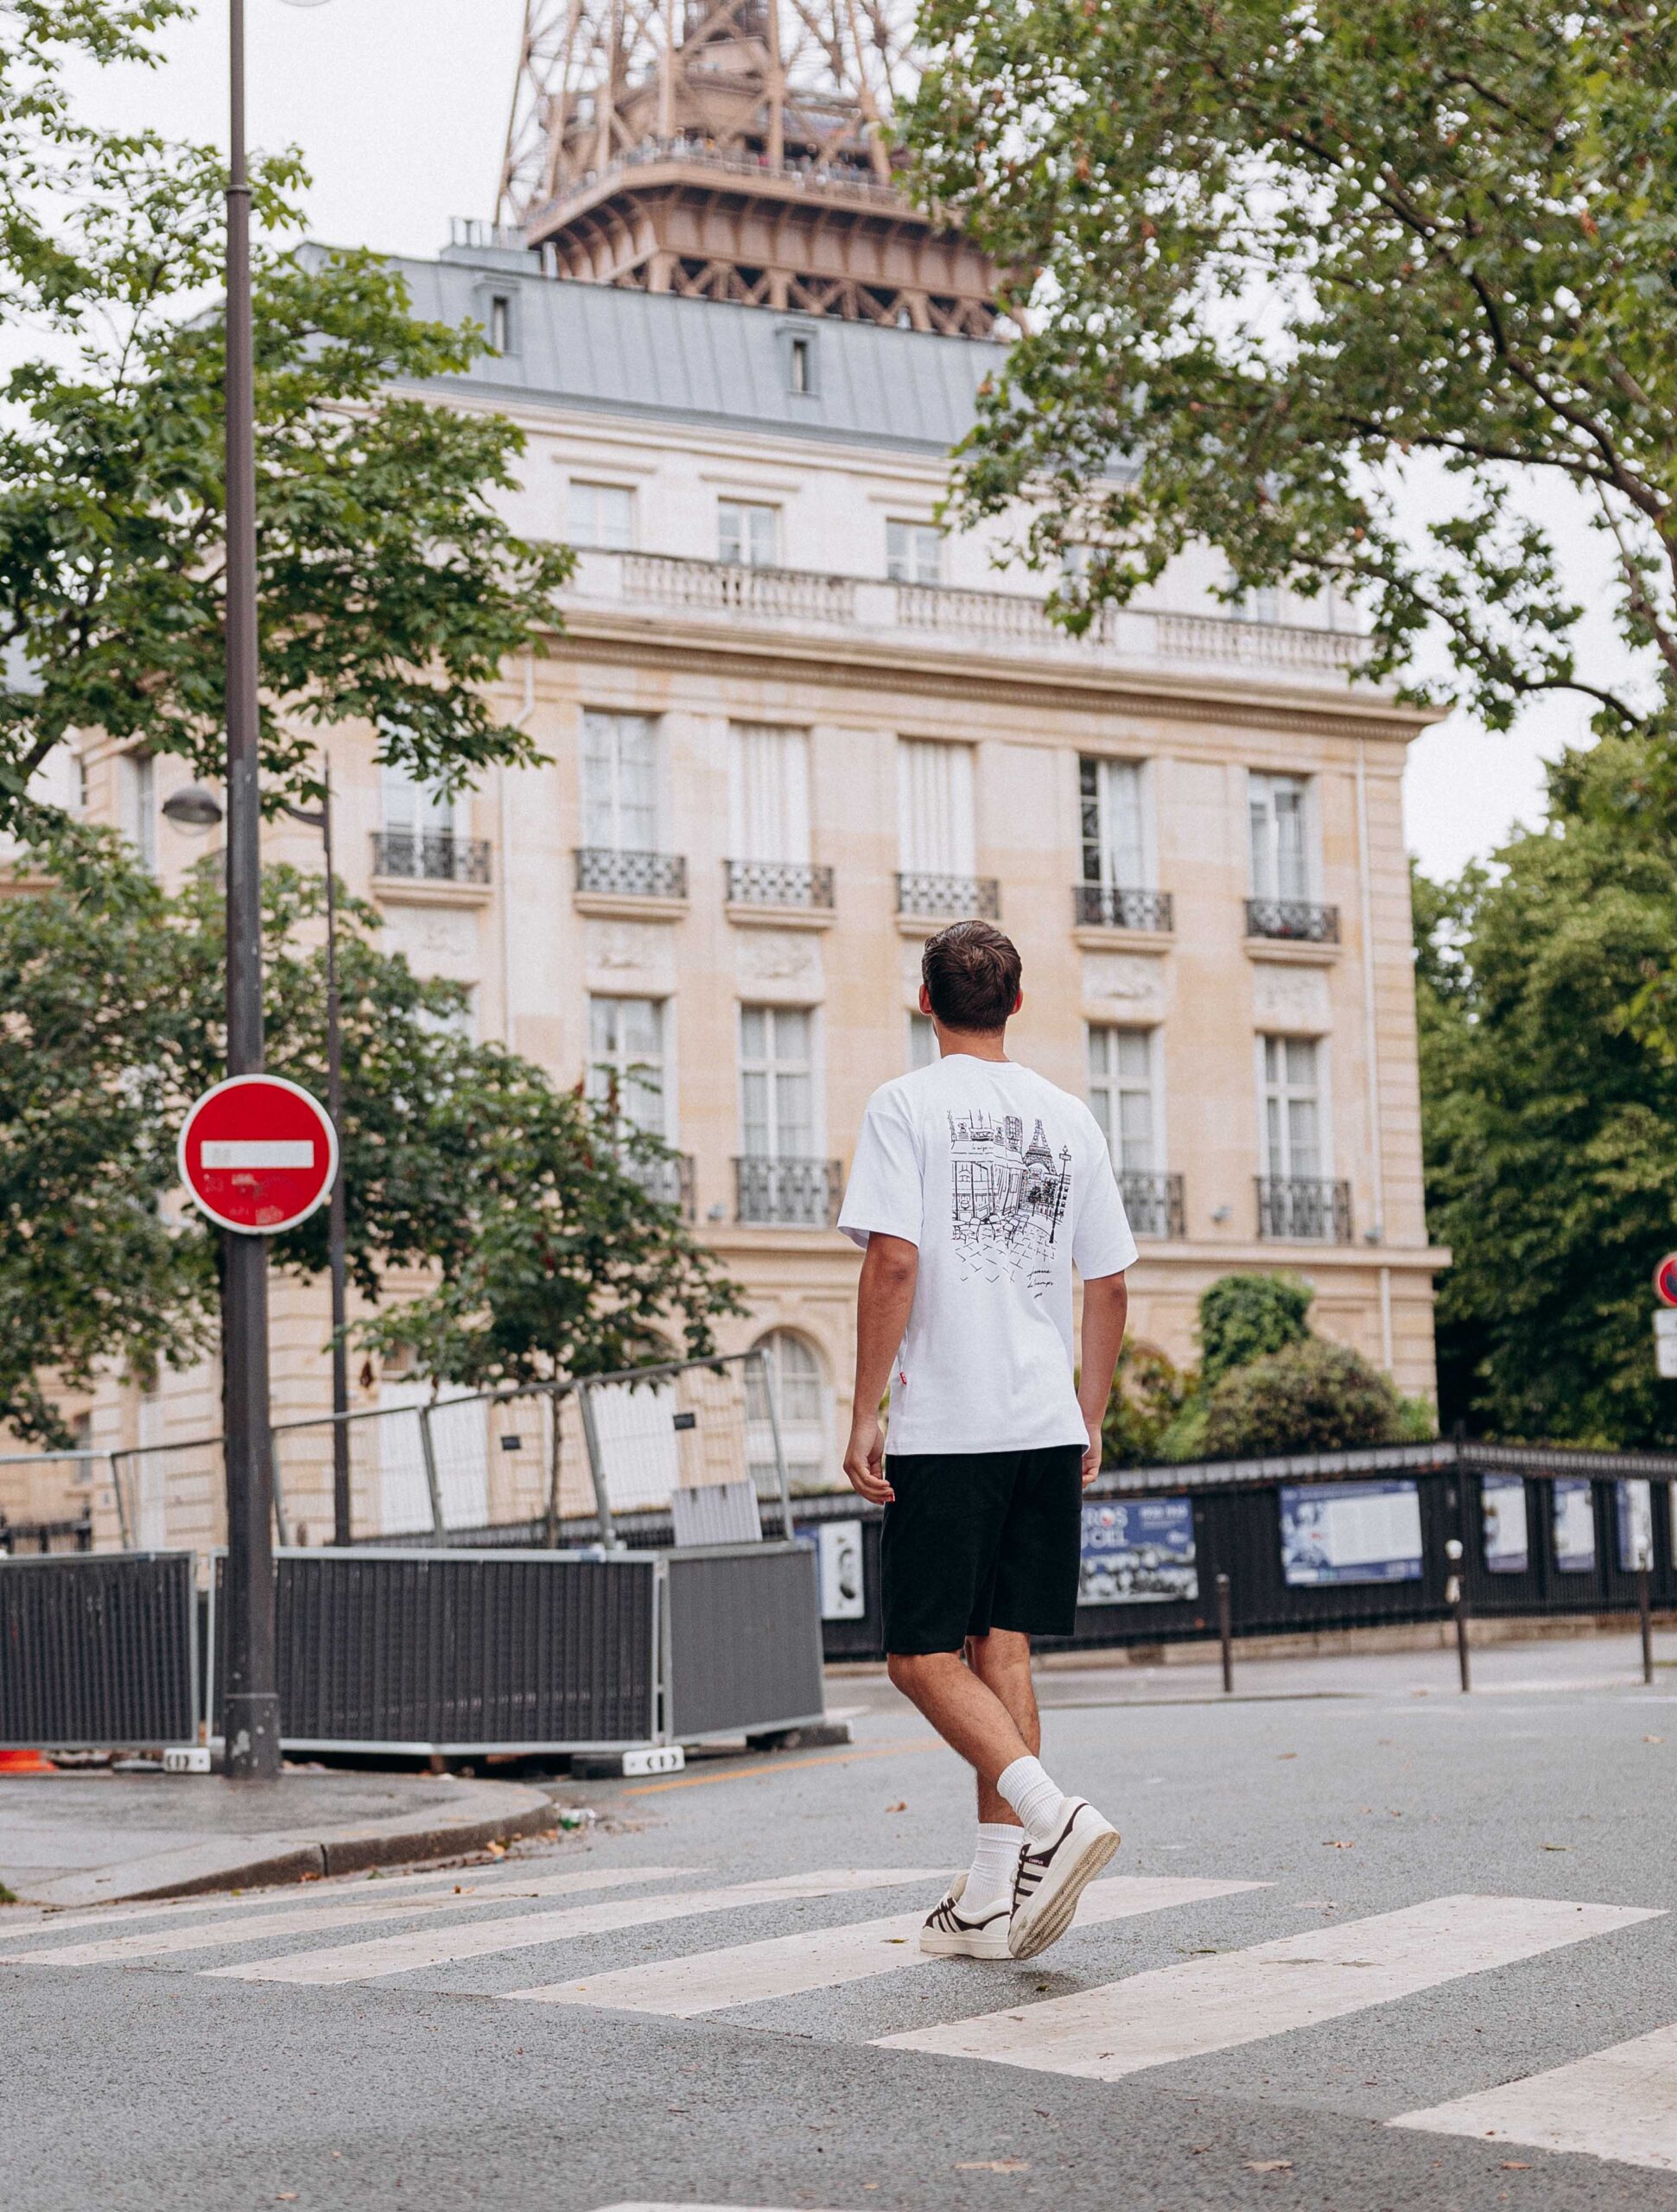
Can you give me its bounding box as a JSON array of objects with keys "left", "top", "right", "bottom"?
[{"left": 378, "top": 248, "right": 998, "bottom": 454}]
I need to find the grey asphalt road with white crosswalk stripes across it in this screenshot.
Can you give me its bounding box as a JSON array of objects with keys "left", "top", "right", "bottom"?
[{"left": 0, "top": 1646, "right": 1677, "bottom": 2212}]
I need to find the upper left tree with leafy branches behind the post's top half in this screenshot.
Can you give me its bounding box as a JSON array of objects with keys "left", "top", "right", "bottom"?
[{"left": 0, "top": 0, "right": 571, "bottom": 827}]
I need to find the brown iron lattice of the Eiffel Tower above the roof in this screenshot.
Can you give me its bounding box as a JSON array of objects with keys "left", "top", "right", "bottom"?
[{"left": 498, "top": 0, "right": 995, "bottom": 336}]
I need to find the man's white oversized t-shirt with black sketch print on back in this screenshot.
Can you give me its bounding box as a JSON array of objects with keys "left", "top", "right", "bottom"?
[{"left": 839, "top": 1053, "right": 1135, "bottom": 1451}]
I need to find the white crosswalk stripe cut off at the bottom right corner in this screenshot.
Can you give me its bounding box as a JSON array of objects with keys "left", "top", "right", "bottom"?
[{"left": 1388, "top": 2026, "right": 1677, "bottom": 2174}]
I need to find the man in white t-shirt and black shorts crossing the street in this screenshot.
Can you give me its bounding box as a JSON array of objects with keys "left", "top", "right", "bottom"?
[{"left": 839, "top": 923, "right": 1135, "bottom": 1958}]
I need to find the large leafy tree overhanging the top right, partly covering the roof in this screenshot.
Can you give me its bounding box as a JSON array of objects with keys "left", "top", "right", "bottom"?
[{"left": 909, "top": 0, "right": 1677, "bottom": 730}]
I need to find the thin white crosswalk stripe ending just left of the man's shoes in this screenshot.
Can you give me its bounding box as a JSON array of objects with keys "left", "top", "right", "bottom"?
[{"left": 200, "top": 1867, "right": 940, "bottom": 1988}]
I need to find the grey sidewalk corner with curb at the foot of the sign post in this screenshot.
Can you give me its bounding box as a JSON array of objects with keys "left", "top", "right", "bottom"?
[{"left": 0, "top": 1772, "right": 556, "bottom": 1907}]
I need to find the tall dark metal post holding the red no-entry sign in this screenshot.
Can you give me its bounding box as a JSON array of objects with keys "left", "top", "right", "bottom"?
[{"left": 221, "top": 0, "right": 279, "bottom": 1781}]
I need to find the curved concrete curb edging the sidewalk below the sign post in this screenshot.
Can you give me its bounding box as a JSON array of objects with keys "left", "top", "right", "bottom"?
[{"left": 22, "top": 1783, "right": 557, "bottom": 1909}]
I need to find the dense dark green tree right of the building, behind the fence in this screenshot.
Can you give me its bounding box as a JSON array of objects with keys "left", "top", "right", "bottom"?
[{"left": 1416, "top": 739, "right": 1677, "bottom": 1446}]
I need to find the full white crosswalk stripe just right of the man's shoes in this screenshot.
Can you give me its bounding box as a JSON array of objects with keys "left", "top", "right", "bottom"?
[{"left": 879, "top": 1896, "right": 1660, "bottom": 2082}]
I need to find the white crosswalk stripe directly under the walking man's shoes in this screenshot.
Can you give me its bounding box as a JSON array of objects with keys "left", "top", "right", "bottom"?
[{"left": 519, "top": 1876, "right": 1266, "bottom": 2019}]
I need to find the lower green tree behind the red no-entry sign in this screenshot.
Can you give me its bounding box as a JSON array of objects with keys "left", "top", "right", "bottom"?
[{"left": 0, "top": 836, "right": 741, "bottom": 1442}]
